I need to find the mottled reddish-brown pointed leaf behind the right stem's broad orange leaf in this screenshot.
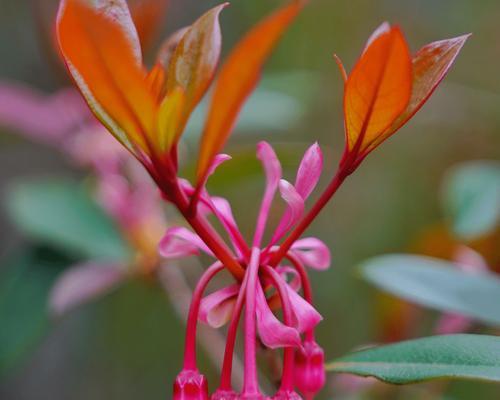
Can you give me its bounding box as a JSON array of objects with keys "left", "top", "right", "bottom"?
[{"left": 384, "top": 35, "right": 470, "bottom": 145}]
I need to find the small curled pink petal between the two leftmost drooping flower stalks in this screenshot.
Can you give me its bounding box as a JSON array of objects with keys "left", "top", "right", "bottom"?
[{"left": 198, "top": 285, "right": 240, "bottom": 328}]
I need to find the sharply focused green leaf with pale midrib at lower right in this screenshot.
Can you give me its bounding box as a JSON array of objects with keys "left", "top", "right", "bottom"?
[{"left": 326, "top": 335, "right": 500, "bottom": 384}]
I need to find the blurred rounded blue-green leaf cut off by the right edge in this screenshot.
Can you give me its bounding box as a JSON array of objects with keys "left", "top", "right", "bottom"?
[{"left": 444, "top": 161, "right": 500, "bottom": 240}]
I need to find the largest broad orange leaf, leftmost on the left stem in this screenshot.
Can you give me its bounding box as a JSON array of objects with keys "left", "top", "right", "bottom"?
[{"left": 57, "top": 0, "right": 157, "bottom": 154}]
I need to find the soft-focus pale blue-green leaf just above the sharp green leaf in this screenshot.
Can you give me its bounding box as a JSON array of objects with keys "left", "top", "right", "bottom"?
[{"left": 361, "top": 254, "right": 500, "bottom": 326}]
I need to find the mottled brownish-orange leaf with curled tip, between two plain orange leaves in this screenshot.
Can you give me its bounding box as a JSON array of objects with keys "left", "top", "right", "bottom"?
[{"left": 167, "top": 3, "right": 227, "bottom": 114}]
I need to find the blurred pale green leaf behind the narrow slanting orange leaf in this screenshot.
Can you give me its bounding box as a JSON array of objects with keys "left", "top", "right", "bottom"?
[{"left": 182, "top": 71, "right": 318, "bottom": 137}]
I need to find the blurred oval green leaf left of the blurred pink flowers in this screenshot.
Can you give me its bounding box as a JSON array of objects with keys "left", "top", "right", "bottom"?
[{"left": 6, "top": 181, "right": 129, "bottom": 261}]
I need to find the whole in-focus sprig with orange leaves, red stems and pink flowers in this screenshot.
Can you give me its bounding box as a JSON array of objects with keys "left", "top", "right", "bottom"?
[{"left": 57, "top": 0, "right": 467, "bottom": 400}]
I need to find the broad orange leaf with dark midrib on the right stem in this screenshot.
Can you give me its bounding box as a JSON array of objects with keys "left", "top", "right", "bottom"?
[{"left": 344, "top": 24, "right": 412, "bottom": 153}]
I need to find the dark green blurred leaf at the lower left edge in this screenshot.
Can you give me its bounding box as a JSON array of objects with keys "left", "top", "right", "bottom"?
[{"left": 0, "top": 248, "right": 71, "bottom": 375}]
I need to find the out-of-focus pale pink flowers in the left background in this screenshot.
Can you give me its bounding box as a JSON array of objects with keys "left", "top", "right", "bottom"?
[{"left": 0, "top": 82, "right": 167, "bottom": 315}]
